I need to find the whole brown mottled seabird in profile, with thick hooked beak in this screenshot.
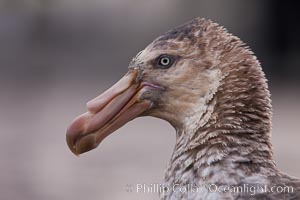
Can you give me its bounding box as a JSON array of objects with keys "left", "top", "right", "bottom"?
[{"left": 67, "top": 18, "right": 300, "bottom": 199}]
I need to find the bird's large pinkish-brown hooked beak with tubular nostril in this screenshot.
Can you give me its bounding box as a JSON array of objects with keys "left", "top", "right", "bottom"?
[{"left": 66, "top": 69, "right": 163, "bottom": 155}]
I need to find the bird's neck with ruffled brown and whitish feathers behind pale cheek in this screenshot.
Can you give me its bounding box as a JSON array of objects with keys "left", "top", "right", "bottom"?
[{"left": 164, "top": 61, "right": 276, "bottom": 194}]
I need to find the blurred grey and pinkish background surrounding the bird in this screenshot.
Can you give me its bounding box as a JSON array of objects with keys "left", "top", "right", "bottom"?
[{"left": 0, "top": 0, "right": 300, "bottom": 200}]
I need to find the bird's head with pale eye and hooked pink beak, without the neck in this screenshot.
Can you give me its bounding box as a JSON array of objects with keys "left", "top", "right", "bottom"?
[{"left": 67, "top": 18, "right": 270, "bottom": 155}]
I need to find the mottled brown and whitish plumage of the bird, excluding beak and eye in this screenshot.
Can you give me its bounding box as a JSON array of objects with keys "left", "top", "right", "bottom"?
[{"left": 130, "top": 18, "right": 300, "bottom": 199}]
